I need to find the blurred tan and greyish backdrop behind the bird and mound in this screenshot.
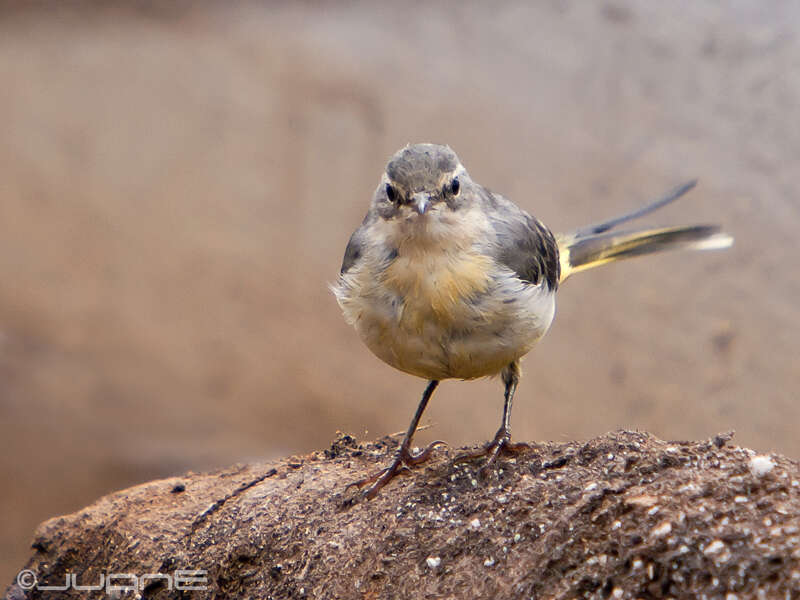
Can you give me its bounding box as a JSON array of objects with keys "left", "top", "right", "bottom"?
[{"left": 0, "top": 0, "right": 800, "bottom": 585}]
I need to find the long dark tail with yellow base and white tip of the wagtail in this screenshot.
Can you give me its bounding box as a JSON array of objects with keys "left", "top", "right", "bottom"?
[{"left": 557, "top": 181, "right": 733, "bottom": 281}]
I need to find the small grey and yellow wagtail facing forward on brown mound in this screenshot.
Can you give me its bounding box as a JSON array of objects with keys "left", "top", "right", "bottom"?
[{"left": 332, "top": 144, "right": 733, "bottom": 498}]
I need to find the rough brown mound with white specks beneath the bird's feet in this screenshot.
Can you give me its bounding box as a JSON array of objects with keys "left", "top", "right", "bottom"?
[{"left": 6, "top": 431, "right": 800, "bottom": 600}]
